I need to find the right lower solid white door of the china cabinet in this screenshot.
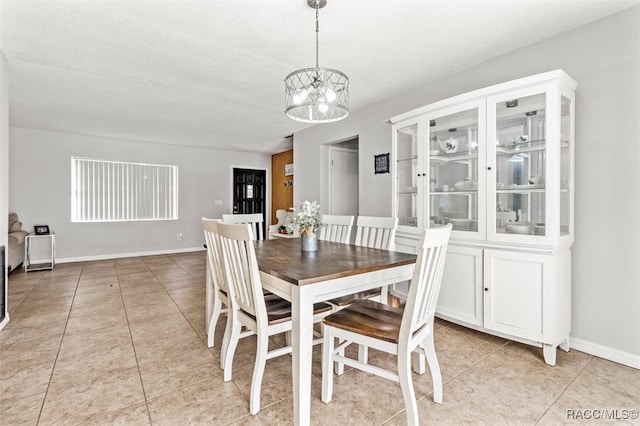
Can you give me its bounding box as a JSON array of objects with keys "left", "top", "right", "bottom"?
[{"left": 484, "top": 250, "right": 551, "bottom": 341}]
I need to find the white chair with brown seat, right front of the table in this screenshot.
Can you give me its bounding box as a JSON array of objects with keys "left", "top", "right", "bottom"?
[{"left": 322, "top": 224, "right": 451, "bottom": 425}]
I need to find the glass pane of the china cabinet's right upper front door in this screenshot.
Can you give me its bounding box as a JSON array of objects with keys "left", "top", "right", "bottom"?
[{"left": 489, "top": 92, "right": 547, "bottom": 237}]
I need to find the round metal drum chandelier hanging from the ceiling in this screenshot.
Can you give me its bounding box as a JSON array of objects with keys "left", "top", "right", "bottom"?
[{"left": 284, "top": 0, "right": 349, "bottom": 123}]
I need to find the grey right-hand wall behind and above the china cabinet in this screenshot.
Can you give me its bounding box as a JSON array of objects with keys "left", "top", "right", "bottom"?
[{"left": 294, "top": 6, "right": 640, "bottom": 367}]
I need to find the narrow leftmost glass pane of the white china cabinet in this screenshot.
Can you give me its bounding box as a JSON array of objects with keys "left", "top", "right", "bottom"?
[{"left": 395, "top": 123, "right": 422, "bottom": 226}]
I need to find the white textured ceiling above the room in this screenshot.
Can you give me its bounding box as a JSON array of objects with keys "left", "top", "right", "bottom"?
[{"left": 0, "top": 0, "right": 638, "bottom": 153}]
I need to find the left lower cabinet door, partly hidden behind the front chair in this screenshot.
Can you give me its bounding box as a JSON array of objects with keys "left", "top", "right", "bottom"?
[{"left": 436, "top": 244, "right": 482, "bottom": 326}]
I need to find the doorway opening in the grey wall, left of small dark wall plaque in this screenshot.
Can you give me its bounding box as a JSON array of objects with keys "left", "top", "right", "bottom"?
[{"left": 328, "top": 136, "right": 359, "bottom": 216}]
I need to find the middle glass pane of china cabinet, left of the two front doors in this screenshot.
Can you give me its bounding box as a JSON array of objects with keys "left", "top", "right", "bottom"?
[{"left": 425, "top": 104, "right": 484, "bottom": 237}]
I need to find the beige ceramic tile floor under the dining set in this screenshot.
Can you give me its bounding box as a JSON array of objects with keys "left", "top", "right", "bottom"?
[{"left": 0, "top": 252, "right": 640, "bottom": 425}]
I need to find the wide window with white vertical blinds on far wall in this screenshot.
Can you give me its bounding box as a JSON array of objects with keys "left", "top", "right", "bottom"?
[{"left": 71, "top": 157, "right": 178, "bottom": 222}]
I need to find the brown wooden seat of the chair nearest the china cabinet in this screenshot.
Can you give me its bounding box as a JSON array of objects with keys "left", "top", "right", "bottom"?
[{"left": 322, "top": 299, "right": 404, "bottom": 343}]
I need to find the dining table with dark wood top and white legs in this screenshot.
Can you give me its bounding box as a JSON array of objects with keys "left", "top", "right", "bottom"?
[{"left": 255, "top": 238, "right": 416, "bottom": 425}]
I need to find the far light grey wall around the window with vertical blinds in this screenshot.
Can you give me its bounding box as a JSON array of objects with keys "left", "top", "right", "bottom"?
[{"left": 5, "top": 127, "right": 271, "bottom": 261}]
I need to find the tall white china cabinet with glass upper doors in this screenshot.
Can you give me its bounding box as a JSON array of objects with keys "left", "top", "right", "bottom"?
[{"left": 390, "top": 70, "right": 577, "bottom": 365}]
